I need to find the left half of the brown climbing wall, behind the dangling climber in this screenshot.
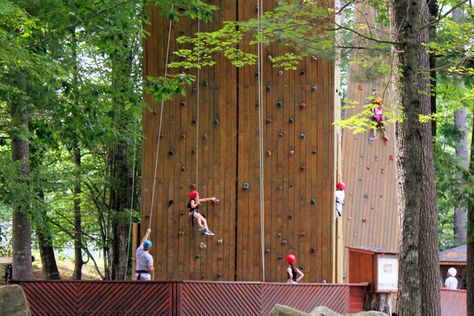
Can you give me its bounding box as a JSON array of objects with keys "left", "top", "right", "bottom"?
[{"left": 142, "top": 6, "right": 237, "bottom": 280}]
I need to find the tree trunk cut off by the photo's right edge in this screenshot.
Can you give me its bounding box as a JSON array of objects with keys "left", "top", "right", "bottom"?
[{"left": 466, "top": 111, "right": 474, "bottom": 316}]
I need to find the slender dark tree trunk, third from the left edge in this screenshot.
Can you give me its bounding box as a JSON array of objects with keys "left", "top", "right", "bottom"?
[{"left": 72, "top": 148, "right": 84, "bottom": 280}]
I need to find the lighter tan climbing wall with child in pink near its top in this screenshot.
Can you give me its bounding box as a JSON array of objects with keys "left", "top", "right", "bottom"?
[{"left": 342, "top": 3, "right": 399, "bottom": 277}]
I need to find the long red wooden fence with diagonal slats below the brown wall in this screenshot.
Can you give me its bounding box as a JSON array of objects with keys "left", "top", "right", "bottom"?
[{"left": 11, "top": 281, "right": 365, "bottom": 316}]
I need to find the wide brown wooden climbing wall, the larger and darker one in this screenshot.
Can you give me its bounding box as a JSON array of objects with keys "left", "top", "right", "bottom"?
[{"left": 142, "top": 0, "right": 335, "bottom": 282}]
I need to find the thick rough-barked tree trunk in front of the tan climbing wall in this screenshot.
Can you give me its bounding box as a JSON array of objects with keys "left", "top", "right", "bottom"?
[{"left": 391, "top": 0, "right": 441, "bottom": 316}]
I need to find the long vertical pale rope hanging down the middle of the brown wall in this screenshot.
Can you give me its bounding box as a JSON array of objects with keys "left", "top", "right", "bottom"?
[{"left": 257, "top": 0, "right": 265, "bottom": 282}]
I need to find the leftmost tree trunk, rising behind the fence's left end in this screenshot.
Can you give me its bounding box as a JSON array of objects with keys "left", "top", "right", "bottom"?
[{"left": 10, "top": 78, "right": 33, "bottom": 280}]
